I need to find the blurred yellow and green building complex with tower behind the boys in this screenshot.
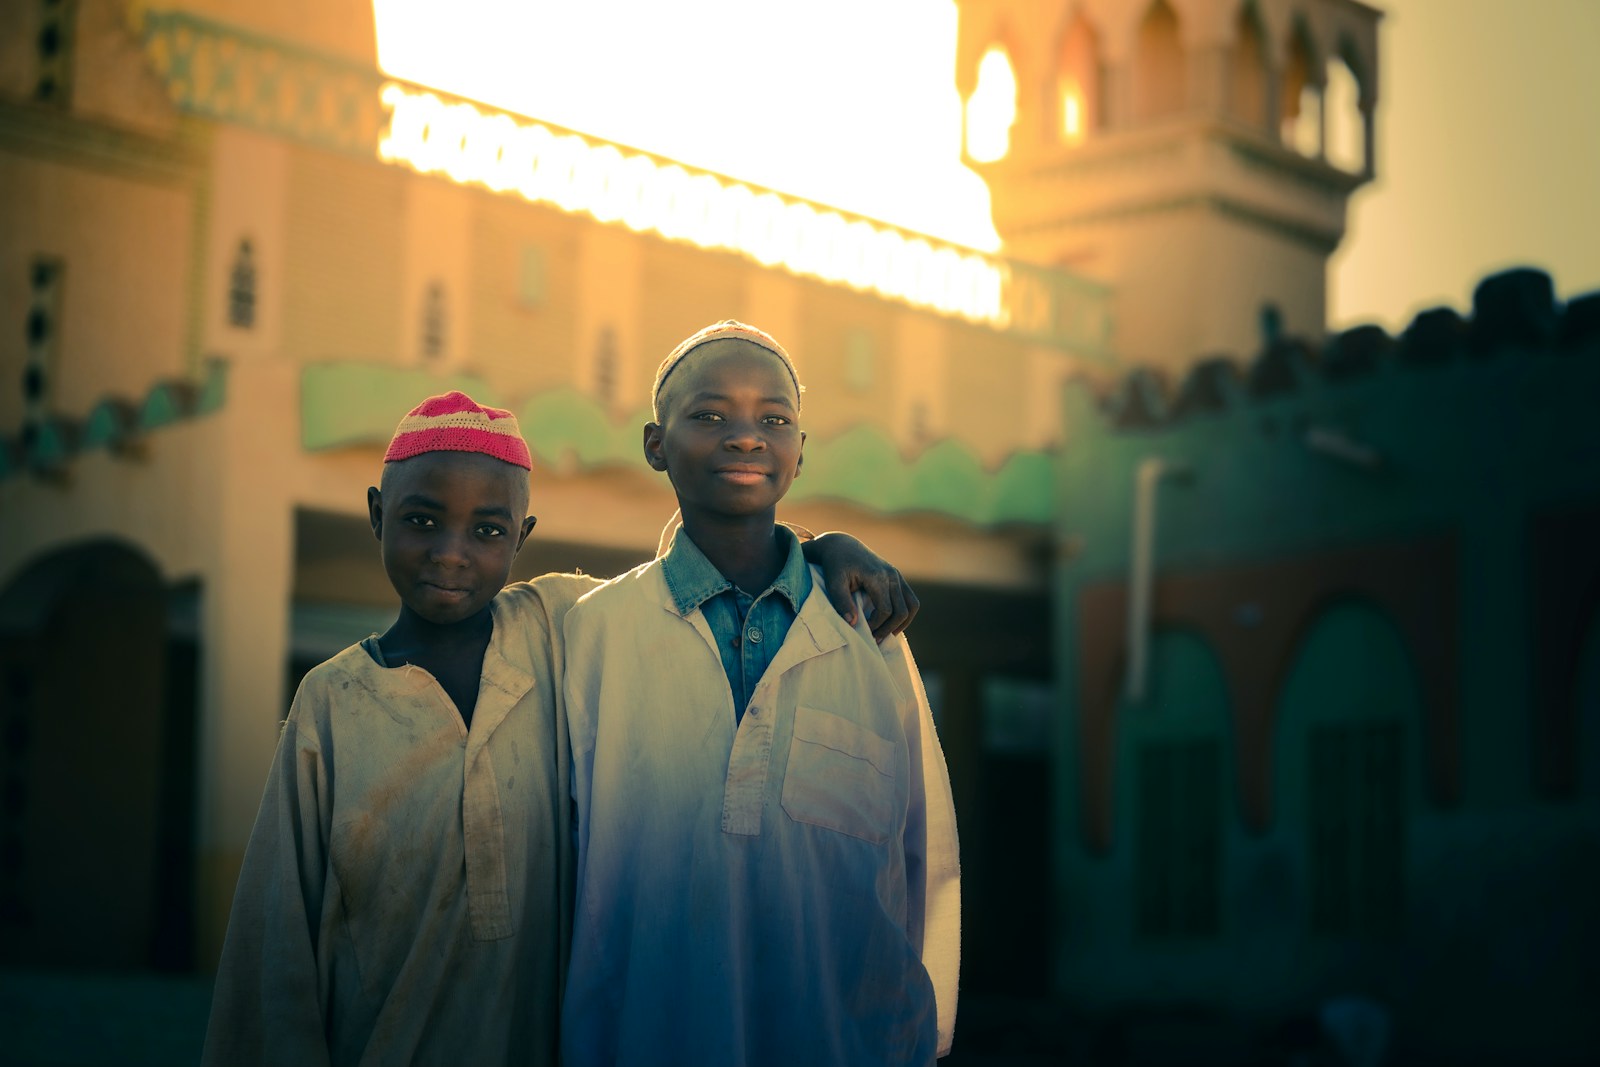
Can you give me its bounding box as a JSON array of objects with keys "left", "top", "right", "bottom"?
[{"left": 0, "top": 0, "right": 1600, "bottom": 1064}]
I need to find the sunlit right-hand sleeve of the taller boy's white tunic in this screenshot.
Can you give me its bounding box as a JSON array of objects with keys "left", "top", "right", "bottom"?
[{"left": 878, "top": 633, "right": 962, "bottom": 1056}]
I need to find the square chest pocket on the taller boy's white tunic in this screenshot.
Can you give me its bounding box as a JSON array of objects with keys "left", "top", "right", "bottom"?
[{"left": 781, "top": 705, "right": 899, "bottom": 845}]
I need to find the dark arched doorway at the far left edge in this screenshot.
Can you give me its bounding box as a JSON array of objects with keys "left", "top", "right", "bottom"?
[{"left": 0, "top": 541, "right": 192, "bottom": 968}]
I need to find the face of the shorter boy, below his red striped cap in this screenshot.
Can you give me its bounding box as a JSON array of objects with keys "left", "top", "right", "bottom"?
[{"left": 366, "top": 453, "right": 534, "bottom": 625}]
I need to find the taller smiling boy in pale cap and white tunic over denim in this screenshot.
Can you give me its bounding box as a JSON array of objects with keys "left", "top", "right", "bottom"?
[{"left": 562, "top": 322, "right": 960, "bottom": 1067}]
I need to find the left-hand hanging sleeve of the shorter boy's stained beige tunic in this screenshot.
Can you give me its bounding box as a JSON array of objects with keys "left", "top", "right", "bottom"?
[{"left": 202, "top": 686, "right": 330, "bottom": 1067}]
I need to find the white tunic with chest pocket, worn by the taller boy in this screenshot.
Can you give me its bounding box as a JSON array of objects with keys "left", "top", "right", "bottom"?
[{"left": 562, "top": 561, "right": 960, "bottom": 1067}]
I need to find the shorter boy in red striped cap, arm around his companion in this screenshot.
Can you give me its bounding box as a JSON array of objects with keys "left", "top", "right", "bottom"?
[{"left": 205, "top": 392, "right": 914, "bottom": 1067}]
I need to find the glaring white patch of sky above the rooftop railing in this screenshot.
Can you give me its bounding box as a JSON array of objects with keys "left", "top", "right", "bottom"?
[{"left": 373, "top": 0, "right": 1014, "bottom": 251}]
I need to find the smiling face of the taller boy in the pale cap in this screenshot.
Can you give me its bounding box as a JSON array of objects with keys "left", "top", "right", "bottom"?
[{"left": 645, "top": 338, "right": 805, "bottom": 517}]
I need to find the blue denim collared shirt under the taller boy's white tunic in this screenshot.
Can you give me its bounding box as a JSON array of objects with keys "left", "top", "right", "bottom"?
[{"left": 661, "top": 526, "right": 811, "bottom": 721}]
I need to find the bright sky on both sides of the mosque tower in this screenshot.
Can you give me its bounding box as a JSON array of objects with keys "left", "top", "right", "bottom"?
[{"left": 374, "top": 0, "right": 1600, "bottom": 330}]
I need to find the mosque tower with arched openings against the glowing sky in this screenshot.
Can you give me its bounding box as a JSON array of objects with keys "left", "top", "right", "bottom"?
[{"left": 957, "top": 0, "right": 1381, "bottom": 370}]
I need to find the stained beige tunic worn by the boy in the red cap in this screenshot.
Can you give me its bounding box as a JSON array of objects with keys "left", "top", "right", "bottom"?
[{"left": 205, "top": 574, "right": 598, "bottom": 1067}]
